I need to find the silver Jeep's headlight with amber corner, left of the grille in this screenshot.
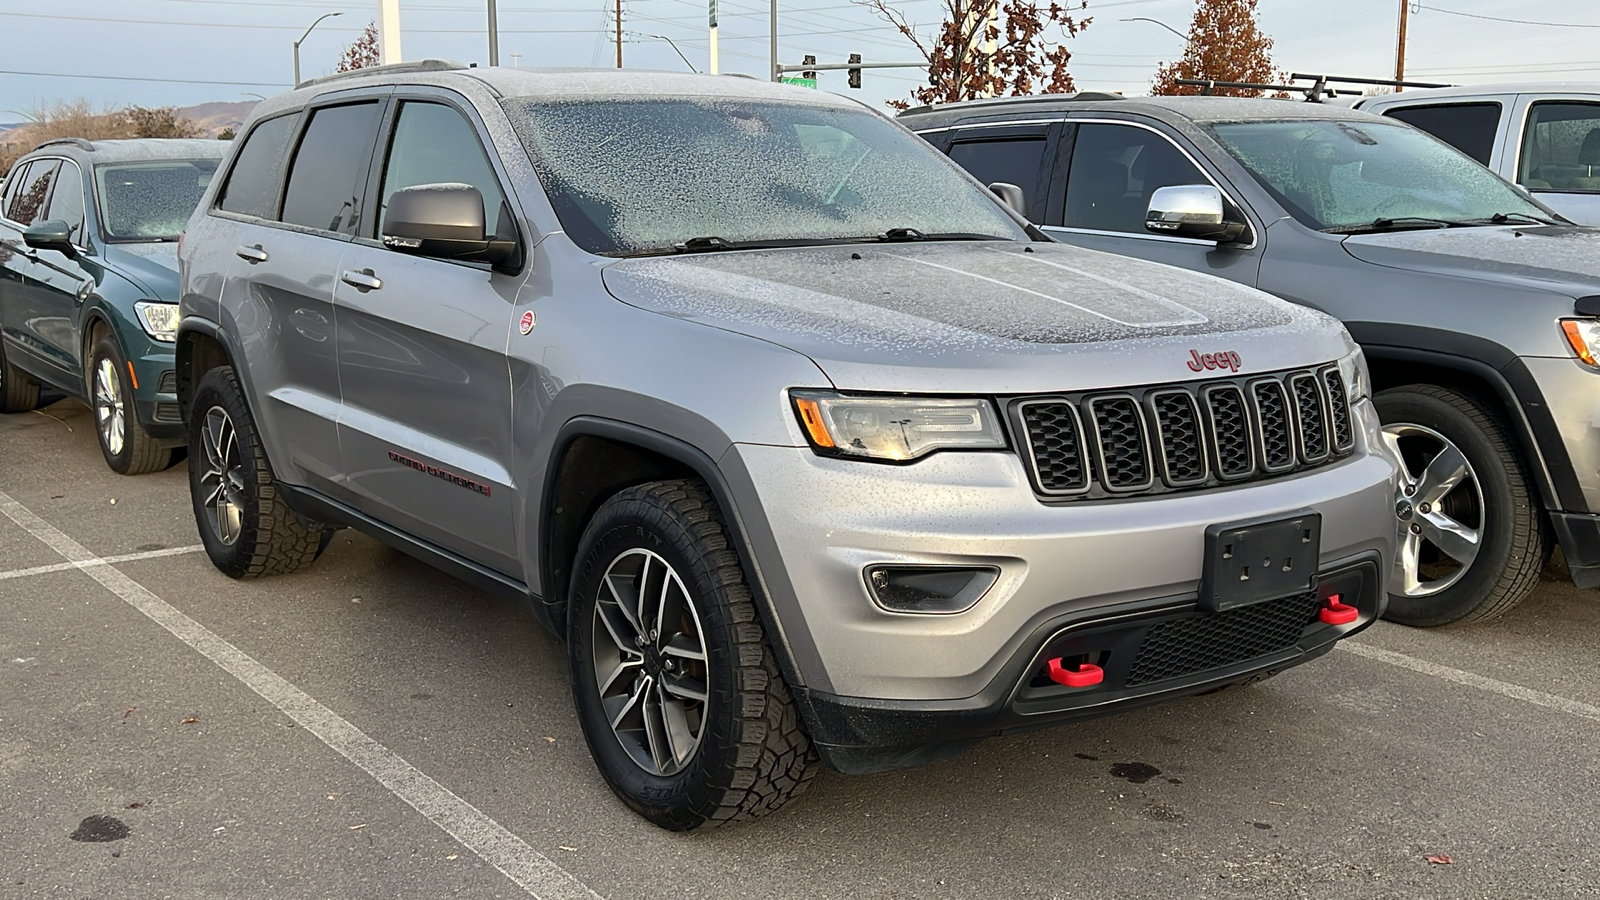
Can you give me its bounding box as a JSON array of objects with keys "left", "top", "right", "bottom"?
[{"left": 792, "top": 391, "right": 1006, "bottom": 463}]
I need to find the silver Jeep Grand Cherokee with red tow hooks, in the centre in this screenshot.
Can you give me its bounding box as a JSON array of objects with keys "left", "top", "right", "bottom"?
[{"left": 178, "top": 62, "right": 1397, "bottom": 830}]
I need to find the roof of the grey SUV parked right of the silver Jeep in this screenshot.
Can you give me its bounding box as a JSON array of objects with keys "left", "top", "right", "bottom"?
[{"left": 901, "top": 94, "right": 1376, "bottom": 130}]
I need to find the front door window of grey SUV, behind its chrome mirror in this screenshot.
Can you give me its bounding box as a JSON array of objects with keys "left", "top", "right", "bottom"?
[{"left": 1061, "top": 123, "right": 1211, "bottom": 234}]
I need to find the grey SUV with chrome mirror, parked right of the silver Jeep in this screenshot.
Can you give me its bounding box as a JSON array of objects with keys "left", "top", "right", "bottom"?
[{"left": 901, "top": 91, "right": 1600, "bottom": 625}]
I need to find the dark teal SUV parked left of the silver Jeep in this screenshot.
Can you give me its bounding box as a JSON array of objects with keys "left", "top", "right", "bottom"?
[{"left": 0, "top": 138, "right": 227, "bottom": 476}]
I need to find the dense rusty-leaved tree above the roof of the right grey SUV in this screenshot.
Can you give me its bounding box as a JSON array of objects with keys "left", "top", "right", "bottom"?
[{"left": 1150, "top": 0, "right": 1285, "bottom": 96}]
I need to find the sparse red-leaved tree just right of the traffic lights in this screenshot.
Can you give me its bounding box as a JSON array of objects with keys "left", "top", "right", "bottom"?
[{"left": 854, "top": 0, "right": 1090, "bottom": 109}]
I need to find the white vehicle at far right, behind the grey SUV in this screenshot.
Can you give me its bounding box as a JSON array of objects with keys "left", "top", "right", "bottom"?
[{"left": 1355, "top": 83, "right": 1600, "bottom": 226}]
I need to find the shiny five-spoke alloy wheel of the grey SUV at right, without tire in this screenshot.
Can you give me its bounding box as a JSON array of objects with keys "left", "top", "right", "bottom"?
[{"left": 1382, "top": 423, "right": 1485, "bottom": 597}]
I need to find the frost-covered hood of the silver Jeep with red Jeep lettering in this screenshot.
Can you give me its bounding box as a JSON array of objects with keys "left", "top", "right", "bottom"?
[{"left": 605, "top": 242, "right": 1354, "bottom": 394}]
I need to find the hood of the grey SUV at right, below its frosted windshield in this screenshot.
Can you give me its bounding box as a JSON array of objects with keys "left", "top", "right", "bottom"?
[{"left": 1344, "top": 226, "right": 1600, "bottom": 296}]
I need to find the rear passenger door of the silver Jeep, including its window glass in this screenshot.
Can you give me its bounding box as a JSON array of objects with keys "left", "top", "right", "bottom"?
[{"left": 218, "top": 96, "right": 387, "bottom": 498}]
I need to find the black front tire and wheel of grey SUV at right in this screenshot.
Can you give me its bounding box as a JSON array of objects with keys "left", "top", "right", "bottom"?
[{"left": 1373, "top": 384, "right": 1550, "bottom": 626}]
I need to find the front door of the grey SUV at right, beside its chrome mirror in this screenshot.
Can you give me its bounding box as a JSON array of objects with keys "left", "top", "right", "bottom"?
[{"left": 1045, "top": 122, "right": 1266, "bottom": 285}]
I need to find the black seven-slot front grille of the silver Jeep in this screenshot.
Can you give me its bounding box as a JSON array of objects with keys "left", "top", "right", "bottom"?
[{"left": 1010, "top": 367, "right": 1355, "bottom": 500}]
